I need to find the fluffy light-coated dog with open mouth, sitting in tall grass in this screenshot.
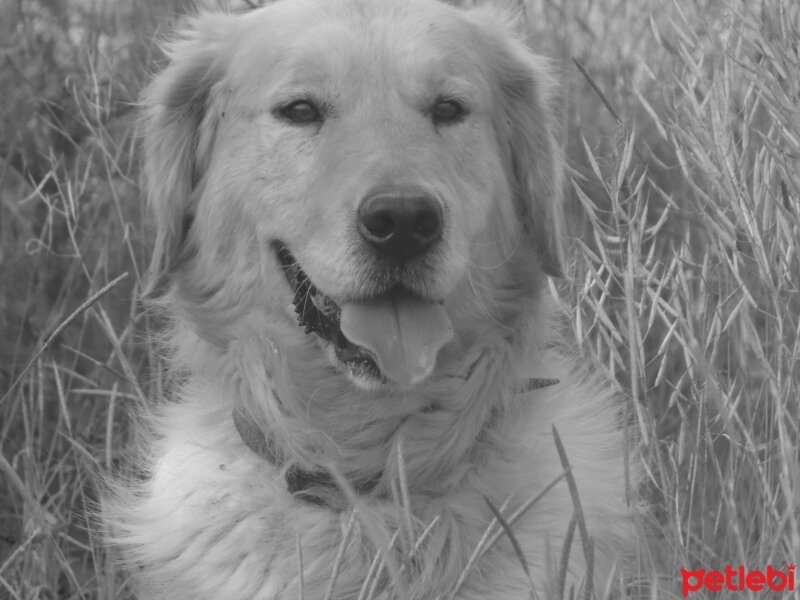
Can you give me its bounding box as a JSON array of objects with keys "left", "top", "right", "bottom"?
[{"left": 103, "top": 0, "right": 638, "bottom": 600}]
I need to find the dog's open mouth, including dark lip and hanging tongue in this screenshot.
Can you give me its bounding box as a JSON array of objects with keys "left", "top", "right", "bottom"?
[{"left": 275, "top": 243, "right": 453, "bottom": 385}]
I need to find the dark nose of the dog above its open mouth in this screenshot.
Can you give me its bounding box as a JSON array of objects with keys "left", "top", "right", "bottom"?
[{"left": 358, "top": 190, "right": 442, "bottom": 262}]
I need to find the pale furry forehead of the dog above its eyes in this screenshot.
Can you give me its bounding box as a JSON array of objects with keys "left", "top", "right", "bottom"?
[{"left": 234, "top": 0, "right": 485, "bottom": 87}]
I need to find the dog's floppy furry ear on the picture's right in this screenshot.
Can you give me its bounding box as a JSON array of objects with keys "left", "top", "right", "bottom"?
[{"left": 483, "top": 12, "right": 566, "bottom": 277}]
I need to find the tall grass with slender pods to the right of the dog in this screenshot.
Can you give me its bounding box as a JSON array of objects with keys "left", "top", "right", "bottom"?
[{"left": 552, "top": 2, "right": 800, "bottom": 597}]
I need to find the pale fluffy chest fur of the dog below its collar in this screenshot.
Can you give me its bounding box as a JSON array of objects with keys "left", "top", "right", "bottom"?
[{"left": 106, "top": 328, "right": 632, "bottom": 599}]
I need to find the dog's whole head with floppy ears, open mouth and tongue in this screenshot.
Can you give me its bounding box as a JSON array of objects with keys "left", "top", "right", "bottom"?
[{"left": 145, "top": 0, "right": 562, "bottom": 387}]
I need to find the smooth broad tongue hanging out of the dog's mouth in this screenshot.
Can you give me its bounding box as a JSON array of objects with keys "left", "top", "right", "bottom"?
[{"left": 340, "top": 295, "right": 453, "bottom": 385}]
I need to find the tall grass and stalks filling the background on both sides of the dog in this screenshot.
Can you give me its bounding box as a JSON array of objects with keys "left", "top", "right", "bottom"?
[{"left": 0, "top": 0, "right": 800, "bottom": 599}]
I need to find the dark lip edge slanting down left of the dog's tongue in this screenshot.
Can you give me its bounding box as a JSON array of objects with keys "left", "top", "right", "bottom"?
[{"left": 273, "top": 242, "right": 386, "bottom": 383}]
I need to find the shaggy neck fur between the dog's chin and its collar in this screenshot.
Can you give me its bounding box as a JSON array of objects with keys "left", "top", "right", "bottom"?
[{"left": 166, "top": 272, "right": 546, "bottom": 495}]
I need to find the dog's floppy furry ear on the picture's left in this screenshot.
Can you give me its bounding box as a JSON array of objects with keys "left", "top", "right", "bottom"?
[{"left": 142, "top": 14, "right": 234, "bottom": 294}]
